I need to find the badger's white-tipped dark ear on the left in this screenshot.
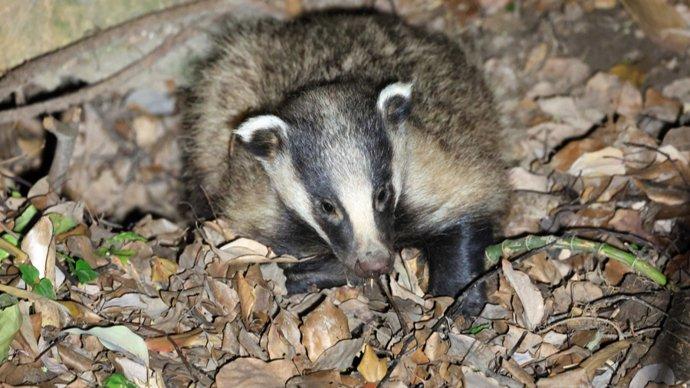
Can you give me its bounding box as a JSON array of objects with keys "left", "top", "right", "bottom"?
[{"left": 235, "top": 115, "right": 288, "bottom": 160}]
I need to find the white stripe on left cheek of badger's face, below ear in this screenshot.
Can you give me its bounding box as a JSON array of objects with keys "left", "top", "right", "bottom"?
[{"left": 264, "top": 155, "right": 330, "bottom": 244}]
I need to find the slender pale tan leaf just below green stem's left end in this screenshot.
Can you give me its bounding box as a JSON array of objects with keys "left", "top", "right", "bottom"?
[{"left": 501, "top": 259, "right": 544, "bottom": 330}]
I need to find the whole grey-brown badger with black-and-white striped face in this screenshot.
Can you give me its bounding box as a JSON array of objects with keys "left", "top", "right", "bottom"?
[{"left": 184, "top": 11, "right": 508, "bottom": 312}]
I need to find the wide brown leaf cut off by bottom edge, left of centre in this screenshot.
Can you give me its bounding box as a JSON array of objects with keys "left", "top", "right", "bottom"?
[{"left": 216, "top": 358, "right": 297, "bottom": 388}]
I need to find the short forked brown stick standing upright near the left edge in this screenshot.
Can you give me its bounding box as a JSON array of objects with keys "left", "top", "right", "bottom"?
[{"left": 43, "top": 107, "right": 81, "bottom": 193}]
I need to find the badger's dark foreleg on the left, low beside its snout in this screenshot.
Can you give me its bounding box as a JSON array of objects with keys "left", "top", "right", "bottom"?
[{"left": 283, "top": 255, "right": 362, "bottom": 294}]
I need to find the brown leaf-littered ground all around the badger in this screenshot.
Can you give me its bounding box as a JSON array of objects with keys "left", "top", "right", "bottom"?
[{"left": 0, "top": 0, "right": 690, "bottom": 387}]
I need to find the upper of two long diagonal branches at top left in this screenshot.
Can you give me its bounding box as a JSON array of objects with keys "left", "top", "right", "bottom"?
[{"left": 0, "top": 0, "right": 239, "bottom": 99}]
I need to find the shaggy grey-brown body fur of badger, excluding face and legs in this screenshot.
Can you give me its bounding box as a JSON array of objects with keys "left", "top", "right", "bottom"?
[{"left": 184, "top": 8, "right": 508, "bottom": 306}]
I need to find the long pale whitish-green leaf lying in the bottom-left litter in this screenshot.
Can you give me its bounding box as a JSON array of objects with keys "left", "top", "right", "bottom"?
[{"left": 63, "top": 326, "right": 149, "bottom": 367}]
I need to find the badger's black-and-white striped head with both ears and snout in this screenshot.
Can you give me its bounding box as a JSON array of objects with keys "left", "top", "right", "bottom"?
[{"left": 236, "top": 83, "right": 412, "bottom": 277}]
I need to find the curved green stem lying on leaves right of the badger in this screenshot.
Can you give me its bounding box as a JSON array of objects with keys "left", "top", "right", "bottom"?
[{"left": 485, "top": 235, "right": 667, "bottom": 286}]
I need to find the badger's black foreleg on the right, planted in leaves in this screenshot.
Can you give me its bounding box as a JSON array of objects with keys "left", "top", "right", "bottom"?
[{"left": 422, "top": 220, "right": 493, "bottom": 316}]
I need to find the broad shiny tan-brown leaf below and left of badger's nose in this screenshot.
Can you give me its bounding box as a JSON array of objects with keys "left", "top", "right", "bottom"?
[{"left": 300, "top": 298, "right": 350, "bottom": 362}]
